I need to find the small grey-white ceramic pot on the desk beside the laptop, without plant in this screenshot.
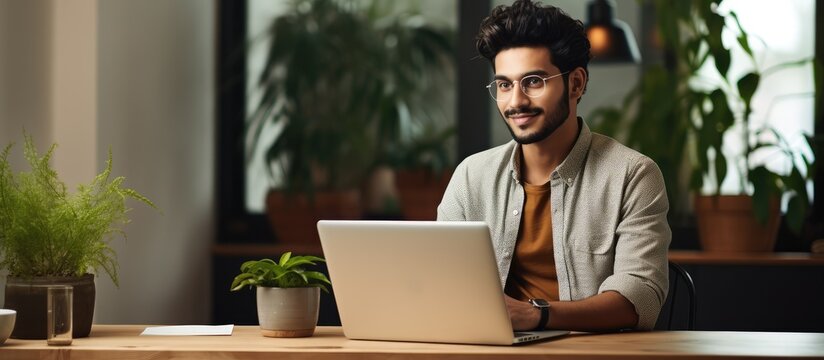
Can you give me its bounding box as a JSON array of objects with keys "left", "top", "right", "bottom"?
[{"left": 257, "top": 286, "right": 320, "bottom": 337}]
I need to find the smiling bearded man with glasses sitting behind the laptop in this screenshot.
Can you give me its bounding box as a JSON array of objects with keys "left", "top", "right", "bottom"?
[{"left": 438, "top": 0, "right": 671, "bottom": 331}]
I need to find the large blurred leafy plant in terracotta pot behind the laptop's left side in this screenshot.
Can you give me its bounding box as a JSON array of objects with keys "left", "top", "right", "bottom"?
[{"left": 246, "top": 0, "right": 452, "bottom": 244}]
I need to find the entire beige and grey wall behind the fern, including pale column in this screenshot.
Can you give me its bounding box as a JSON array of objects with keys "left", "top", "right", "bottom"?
[{"left": 0, "top": 0, "right": 216, "bottom": 324}]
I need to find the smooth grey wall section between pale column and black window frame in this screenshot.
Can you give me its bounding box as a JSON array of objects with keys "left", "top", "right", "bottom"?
[{"left": 97, "top": 0, "right": 216, "bottom": 323}]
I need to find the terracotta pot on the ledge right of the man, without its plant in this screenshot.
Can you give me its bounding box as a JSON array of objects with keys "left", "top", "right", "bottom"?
[{"left": 695, "top": 195, "right": 780, "bottom": 252}]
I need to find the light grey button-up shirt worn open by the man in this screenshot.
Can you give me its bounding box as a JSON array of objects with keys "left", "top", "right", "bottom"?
[{"left": 438, "top": 119, "right": 672, "bottom": 329}]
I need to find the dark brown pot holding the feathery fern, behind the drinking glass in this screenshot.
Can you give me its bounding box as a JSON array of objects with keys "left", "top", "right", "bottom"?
[{"left": 5, "top": 274, "right": 95, "bottom": 339}]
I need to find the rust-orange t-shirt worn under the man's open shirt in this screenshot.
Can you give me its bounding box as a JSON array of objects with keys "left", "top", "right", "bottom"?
[{"left": 504, "top": 182, "right": 558, "bottom": 301}]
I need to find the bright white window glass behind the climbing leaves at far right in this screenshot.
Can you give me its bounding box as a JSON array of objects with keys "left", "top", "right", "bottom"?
[{"left": 693, "top": 0, "right": 816, "bottom": 200}]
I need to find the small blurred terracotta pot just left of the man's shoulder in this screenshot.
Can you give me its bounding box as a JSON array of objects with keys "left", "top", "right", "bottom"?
[{"left": 395, "top": 170, "right": 452, "bottom": 220}]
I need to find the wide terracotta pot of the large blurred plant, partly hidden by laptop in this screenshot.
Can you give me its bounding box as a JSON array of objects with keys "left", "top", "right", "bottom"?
[{"left": 266, "top": 190, "right": 361, "bottom": 246}]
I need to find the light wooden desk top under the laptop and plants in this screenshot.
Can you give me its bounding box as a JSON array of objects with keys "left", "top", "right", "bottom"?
[{"left": 0, "top": 325, "right": 824, "bottom": 360}]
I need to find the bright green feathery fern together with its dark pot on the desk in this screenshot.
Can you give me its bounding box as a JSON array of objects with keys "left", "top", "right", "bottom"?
[{"left": 0, "top": 136, "right": 155, "bottom": 339}]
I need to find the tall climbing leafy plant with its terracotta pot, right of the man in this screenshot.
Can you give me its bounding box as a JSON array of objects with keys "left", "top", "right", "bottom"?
[{"left": 593, "top": 0, "right": 814, "bottom": 252}]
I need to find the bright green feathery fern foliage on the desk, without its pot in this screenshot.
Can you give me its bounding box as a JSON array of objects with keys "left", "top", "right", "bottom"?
[{"left": 0, "top": 135, "right": 156, "bottom": 285}]
